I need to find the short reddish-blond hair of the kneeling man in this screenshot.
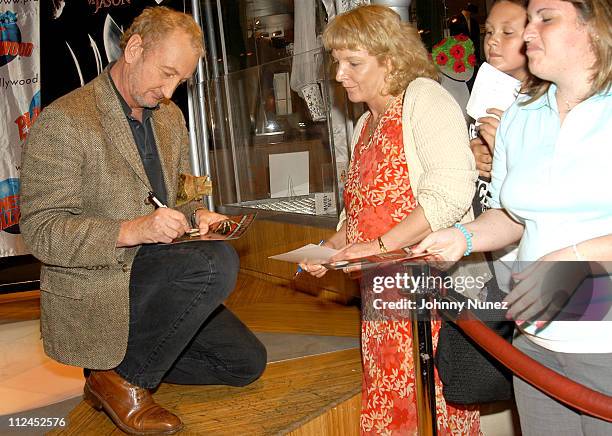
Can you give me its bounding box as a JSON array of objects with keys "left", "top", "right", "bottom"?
[{"left": 120, "top": 6, "right": 204, "bottom": 55}]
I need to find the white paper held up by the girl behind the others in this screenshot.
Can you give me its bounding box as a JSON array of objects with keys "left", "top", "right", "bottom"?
[{"left": 466, "top": 62, "right": 521, "bottom": 120}]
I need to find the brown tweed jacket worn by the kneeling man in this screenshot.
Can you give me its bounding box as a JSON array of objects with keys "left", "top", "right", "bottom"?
[{"left": 20, "top": 69, "right": 195, "bottom": 369}]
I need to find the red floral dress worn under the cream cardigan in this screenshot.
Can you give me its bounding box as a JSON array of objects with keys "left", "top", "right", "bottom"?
[{"left": 344, "top": 94, "right": 480, "bottom": 436}]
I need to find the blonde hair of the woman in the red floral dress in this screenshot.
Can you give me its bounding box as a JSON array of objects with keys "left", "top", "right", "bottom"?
[{"left": 323, "top": 5, "right": 438, "bottom": 95}]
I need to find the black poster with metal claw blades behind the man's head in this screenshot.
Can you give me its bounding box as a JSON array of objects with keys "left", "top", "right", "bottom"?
[{"left": 40, "top": 0, "right": 189, "bottom": 108}]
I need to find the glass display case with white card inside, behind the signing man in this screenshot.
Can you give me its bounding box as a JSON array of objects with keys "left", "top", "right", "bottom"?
[{"left": 207, "top": 49, "right": 346, "bottom": 215}]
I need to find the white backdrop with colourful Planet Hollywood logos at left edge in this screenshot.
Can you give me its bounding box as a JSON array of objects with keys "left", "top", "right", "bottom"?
[{"left": 0, "top": 0, "right": 40, "bottom": 256}]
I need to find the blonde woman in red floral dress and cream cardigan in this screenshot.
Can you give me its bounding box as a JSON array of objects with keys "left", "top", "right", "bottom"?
[{"left": 302, "top": 5, "right": 479, "bottom": 434}]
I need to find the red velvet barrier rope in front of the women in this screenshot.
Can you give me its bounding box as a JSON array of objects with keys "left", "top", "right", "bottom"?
[{"left": 454, "top": 310, "right": 612, "bottom": 422}]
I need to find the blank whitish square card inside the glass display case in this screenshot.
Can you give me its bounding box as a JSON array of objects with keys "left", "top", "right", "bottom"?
[{"left": 268, "top": 151, "right": 310, "bottom": 198}]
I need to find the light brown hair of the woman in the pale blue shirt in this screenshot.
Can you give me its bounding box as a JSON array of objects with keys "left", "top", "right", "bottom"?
[{"left": 526, "top": 0, "right": 612, "bottom": 100}]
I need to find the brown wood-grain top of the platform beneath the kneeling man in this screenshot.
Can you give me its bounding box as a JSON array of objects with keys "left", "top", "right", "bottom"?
[{"left": 52, "top": 349, "right": 361, "bottom": 435}]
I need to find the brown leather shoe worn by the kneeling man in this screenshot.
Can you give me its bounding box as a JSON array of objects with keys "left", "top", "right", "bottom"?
[{"left": 84, "top": 370, "right": 183, "bottom": 434}]
